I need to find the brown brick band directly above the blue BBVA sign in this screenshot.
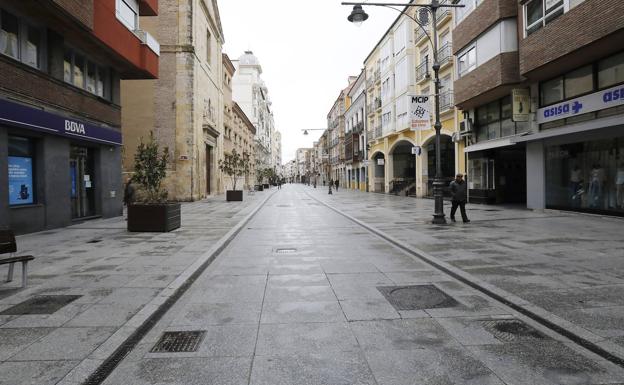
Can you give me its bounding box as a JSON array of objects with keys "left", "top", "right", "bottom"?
[{"left": 0, "top": 57, "right": 121, "bottom": 128}]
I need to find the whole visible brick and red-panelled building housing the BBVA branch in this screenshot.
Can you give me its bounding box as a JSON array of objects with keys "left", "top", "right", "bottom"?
[{"left": 0, "top": 0, "right": 159, "bottom": 233}]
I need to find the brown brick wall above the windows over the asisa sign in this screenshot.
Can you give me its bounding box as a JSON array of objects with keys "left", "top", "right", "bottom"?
[{"left": 519, "top": 0, "right": 624, "bottom": 75}]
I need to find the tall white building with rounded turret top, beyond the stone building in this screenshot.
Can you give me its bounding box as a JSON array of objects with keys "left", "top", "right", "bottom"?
[{"left": 232, "top": 51, "right": 281, "bottom": 169}]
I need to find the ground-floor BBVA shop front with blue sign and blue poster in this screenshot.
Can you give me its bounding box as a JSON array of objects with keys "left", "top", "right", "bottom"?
[{"left": 0, "top": 100, "right": 122, "bottom": 233}]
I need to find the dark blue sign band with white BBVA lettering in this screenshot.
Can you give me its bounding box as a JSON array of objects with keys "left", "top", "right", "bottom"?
[{"left": 0, "top": 99, "right": 121, "bottom": 145}]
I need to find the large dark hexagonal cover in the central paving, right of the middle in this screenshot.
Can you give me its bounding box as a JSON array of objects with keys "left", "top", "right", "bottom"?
[{"left": 377, "top": 285, "right": 457, "bottom": 310}]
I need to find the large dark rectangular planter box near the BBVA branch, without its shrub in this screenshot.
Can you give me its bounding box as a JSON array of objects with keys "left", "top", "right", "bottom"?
[{"left": 128, "top": 203, "right": 182, "bottom": 233}]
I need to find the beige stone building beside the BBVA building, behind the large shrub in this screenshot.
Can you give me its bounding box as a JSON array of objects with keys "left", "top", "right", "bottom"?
[{"left": 122, "top": 0, "right": 224, "bottom": 201}]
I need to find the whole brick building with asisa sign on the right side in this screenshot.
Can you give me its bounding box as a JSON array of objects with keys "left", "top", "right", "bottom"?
[{"left": 454, "top": 0, "right": 624, "bottom": 215}]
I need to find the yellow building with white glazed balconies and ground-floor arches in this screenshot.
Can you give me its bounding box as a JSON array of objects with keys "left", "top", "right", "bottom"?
[{"left": 364, "top": 0, "right": 465, "bottom": 197}]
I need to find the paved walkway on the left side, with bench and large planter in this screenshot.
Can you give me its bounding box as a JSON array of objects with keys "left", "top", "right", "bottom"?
[{"left": 0, "top": 189, "right": 274, "bottom": 385}]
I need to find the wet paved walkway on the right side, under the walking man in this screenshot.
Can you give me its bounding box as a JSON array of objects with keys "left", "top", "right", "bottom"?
[{"left": 310, "top": 183, "right": 624, "bottom": 357}]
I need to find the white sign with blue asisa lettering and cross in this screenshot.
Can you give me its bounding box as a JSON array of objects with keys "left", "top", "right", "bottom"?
[{"left": 537, "top": 85, "right": 624, "bottom": 124}]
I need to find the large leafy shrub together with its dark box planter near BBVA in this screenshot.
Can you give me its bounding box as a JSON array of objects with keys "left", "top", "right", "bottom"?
[{"left": 128, "top": 132, "right": 181, "bottom": 232}]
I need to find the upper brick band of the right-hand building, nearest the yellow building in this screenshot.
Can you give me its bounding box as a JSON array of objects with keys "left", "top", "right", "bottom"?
[{"left": 453, "top": 0, "right": 518, "bottom": 54}]
